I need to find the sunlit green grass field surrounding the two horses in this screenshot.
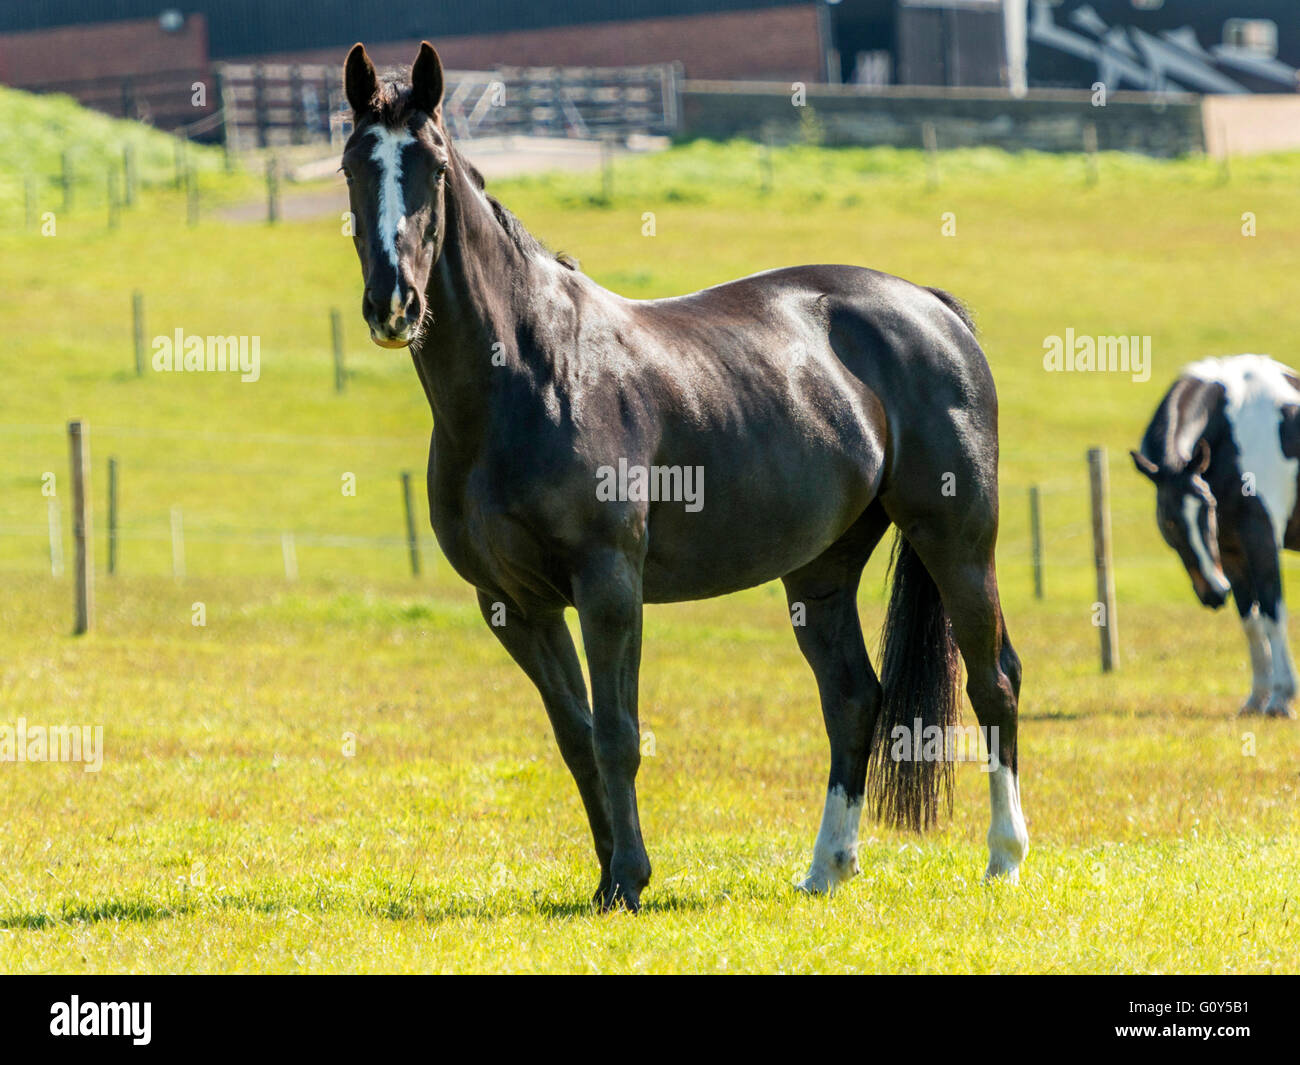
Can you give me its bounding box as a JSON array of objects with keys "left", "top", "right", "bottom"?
[{"left": 0, "top": 89, "right": 1300, "bottom": 973}]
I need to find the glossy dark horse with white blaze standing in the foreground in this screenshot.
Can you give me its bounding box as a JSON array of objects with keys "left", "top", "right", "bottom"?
[{"left": 343, "top": 43, "right": 1028, "bottom": 909}]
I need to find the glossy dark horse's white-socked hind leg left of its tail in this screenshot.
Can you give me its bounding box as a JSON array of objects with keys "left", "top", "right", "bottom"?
[{"left": 784, "top": 506, "right": 889, "bottom": 895}]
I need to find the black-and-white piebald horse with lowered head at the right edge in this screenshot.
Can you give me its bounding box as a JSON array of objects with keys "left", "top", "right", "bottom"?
[{"left": 1131, "top": 355, "right": 1300, "bottom": 718}]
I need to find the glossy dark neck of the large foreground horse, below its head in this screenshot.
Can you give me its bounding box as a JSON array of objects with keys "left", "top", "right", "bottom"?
[{"left": 416, "top": 169, "right": 559, "bottom": 453}]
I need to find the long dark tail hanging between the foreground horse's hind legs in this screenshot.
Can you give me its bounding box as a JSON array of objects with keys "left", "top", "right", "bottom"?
[{"left": 867, "top": 533, "right": 961, "bottom": 831}]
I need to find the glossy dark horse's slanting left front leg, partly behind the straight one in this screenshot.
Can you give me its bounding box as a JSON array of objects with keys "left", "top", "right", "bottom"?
[{"left": 478, "top": 592, "right": 614, "bottom": 902}]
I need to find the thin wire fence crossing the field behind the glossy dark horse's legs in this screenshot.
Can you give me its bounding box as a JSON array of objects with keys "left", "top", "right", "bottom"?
[{"left": 10, "top": 424, "right": 1300, "bottom": 603}]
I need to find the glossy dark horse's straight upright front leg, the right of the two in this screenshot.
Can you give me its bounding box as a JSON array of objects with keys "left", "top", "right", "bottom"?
[{"left": 573, "top": 550, "right": 650, "bottom": 910}]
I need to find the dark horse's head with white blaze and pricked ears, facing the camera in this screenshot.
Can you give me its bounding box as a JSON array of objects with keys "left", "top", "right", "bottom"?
[{"left": 342, "top": 42, "right": 452, "bottom": 347}]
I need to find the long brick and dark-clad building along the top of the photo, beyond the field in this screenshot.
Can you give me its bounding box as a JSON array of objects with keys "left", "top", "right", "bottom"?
[{"left": 0, "top": 0, "right": 1300, "bottom": 133}]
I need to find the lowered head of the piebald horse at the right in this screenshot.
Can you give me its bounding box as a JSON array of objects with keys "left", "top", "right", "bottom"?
[{"left": 1130, "top": 440, "right": 1232, "bottom": 610}]
